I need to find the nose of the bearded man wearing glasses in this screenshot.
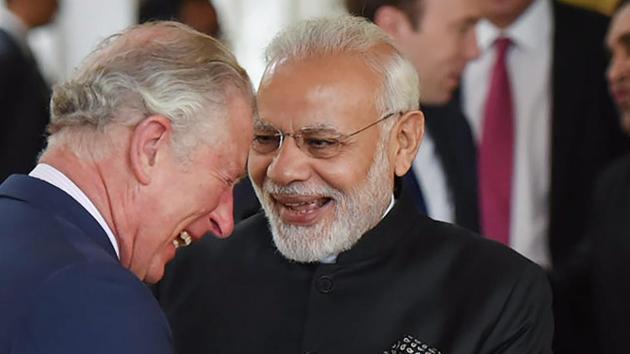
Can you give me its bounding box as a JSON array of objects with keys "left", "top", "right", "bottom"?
[{"left": 267, "top": 135, "right": 310, "bottom": 185}]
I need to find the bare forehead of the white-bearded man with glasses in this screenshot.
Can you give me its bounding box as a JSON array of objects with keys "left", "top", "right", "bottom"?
[{"left": 258, "top": 54, "right": 382, "bottom": 131}]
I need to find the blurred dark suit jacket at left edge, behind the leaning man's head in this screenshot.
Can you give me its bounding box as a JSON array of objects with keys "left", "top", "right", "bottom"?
[{"left": 0, "top": 29, "right": 50, "bottom": 183}]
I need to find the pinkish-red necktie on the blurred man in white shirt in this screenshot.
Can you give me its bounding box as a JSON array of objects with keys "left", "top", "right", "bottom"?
[{"left": 478, "top": 37, "right": 514, "bottom": 245}]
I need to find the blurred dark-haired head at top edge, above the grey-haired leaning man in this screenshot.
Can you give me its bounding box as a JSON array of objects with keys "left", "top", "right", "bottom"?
[{"left": 138, "top": 0, "right": 221, "bottom": 38}]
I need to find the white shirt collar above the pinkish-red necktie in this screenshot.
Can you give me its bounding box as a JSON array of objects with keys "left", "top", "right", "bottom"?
[{"left": 477, "top": 0, "right": 553, "bottom": 51}]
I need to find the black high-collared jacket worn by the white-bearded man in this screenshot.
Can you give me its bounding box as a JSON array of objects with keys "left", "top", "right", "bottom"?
[{"left": 156, "top": 195, "right": 553, "bottom": 354}]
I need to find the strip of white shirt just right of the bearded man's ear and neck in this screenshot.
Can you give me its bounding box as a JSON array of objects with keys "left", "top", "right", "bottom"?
[{"left": 412, "top": 130, "right": 455, "bottom": 223}]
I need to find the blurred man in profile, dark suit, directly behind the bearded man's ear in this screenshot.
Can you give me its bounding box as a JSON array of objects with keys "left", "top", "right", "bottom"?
[{"left": 345, "top": 0, "right": 480, "bottom": 231}]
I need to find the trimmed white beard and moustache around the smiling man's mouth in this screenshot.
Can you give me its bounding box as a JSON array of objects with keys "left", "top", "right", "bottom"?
[{"left": 253, "top": 144, "right": 393, "bottom": 262}]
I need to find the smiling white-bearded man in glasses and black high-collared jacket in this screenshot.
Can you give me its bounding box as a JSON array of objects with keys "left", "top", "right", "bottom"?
[{"left": 156, "top": 16, "right": 553, "bottom": 354}]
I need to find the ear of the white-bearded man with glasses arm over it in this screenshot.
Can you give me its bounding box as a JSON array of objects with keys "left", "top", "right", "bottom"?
[{"left": 391, "top": 111, "right": 424, "bottom": 177}]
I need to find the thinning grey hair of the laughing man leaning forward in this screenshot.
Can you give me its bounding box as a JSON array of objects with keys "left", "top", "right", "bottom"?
[{"left": 44, "top": 22, "right": 254, "bottom": 162}]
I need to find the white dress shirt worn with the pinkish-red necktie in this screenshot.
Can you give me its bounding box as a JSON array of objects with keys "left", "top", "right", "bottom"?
[{"left": 462, "top": 0, "right": 554, "bottom": 268}]
